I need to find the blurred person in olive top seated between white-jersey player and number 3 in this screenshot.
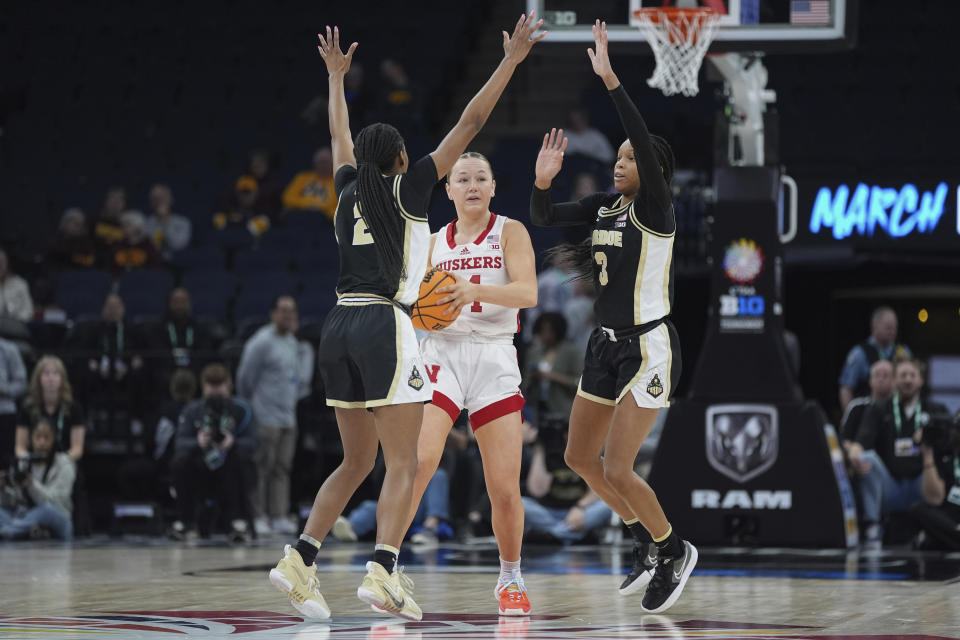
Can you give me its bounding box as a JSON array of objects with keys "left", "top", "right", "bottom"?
[{"left": 523, "top": 311, "right": 583, "bottom": 424}]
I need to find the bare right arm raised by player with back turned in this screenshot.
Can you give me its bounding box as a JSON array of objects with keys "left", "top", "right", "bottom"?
[{"left": 430, "top": 12, "right": 547, "bottom": 179}]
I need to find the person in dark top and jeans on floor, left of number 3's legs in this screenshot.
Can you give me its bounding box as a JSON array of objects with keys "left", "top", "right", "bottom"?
[{"left": 523, "top": 420, "right": 612, "bottom": 544}]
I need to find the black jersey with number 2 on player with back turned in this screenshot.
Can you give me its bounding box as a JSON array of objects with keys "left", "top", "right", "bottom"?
[{"left": 334, "top": 156, "right": 437, "bottom": 306}]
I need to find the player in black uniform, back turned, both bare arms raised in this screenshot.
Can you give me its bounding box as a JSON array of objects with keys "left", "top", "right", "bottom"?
[{"left": 270, "top": 14, "right": 546, "bottom": 620}]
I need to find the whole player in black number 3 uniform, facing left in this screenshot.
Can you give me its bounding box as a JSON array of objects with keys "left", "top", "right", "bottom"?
[{"left": 530, "top": 21, "right": 697, "bottom": 613}]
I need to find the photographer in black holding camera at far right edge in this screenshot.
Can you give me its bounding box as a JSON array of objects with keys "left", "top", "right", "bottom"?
[{"left": 910, "top": 413, "right": 960, "bottom": 551}]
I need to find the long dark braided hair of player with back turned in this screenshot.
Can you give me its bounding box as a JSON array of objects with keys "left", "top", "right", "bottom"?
[{"left": 354, "top": 122, "right": 407, "bottom": 283}]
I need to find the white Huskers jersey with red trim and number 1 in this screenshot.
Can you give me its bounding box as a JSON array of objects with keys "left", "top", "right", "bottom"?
[{"left": 430, "top": 213, "right": 520, "bottom": 343}]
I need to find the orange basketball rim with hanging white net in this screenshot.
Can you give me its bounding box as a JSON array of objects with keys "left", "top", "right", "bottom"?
[{"left": 633, "top": 7, "right": 720, "bottom": 97}]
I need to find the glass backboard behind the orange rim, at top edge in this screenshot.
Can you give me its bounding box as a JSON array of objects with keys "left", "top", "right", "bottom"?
[{"left": 527, "top": 0, "right": 858, "bottom": 53}]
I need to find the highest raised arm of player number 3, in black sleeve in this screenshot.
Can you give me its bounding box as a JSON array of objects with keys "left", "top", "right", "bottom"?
[{"left": 587, "top": 20, "right": 673, "bottom": 211}]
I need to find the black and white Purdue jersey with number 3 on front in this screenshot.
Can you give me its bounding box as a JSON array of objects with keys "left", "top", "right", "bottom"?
[{"left": 591, "top": 196, "right": 676, "bottom": 329}]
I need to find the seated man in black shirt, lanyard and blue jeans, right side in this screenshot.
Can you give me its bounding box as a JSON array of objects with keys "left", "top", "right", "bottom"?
[{"left": 848, "top": 358, "right": 947, "bottom": 549}]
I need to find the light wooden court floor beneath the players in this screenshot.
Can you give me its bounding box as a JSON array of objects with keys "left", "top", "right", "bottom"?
[{"left": 0, "top": 541, "right": 960, "bottom": 640}]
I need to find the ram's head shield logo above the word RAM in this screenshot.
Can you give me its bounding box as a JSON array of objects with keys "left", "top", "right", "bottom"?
[{"left": 706, "top": 404, "right": 780, "bottom": 482}]
